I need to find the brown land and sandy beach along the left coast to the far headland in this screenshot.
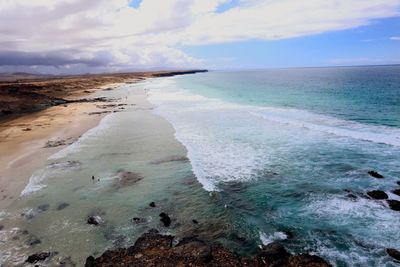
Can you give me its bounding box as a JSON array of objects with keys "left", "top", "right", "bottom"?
[{"left": 0, "top": 71, "right": 206, "bottom": 210}]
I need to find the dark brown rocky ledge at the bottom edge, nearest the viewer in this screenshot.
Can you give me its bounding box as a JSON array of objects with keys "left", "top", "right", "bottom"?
[{"left": 85, "top": 230, "right": 331, "bottom": 267}]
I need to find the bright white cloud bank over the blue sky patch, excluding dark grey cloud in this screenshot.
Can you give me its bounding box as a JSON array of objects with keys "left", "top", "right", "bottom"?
[{"left": 0, "top": 0, "right": 400, "bottom": 72}]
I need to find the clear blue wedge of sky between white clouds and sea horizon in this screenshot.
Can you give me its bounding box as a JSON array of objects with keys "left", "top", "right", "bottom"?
[{"left": 182, "top": 17, "right": 400, "bottom": 68}]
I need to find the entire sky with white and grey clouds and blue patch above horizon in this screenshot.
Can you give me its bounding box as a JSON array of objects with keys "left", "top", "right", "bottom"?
[{"left": 0, "top": 0, "right": 400, "bottom": 74}]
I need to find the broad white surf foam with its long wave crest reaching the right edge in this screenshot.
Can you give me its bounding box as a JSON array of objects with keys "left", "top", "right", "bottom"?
[{"left": 147, "top": 78, "right": 400, "bottom": 191}]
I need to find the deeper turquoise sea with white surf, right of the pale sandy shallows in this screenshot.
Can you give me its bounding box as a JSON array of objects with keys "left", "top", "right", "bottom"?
[{"left": 147, "top": 67, "right": 400, "bottom": 266}]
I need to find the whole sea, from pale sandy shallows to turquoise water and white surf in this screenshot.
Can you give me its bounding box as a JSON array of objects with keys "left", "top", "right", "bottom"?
[{"left": 0, "top": 66, "right": 400, "bottom": 266}]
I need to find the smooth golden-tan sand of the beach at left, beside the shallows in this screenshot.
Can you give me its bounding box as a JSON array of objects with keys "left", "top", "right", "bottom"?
[{"left": 0, "top": 103, "right": 105, "bottom": 209}]
